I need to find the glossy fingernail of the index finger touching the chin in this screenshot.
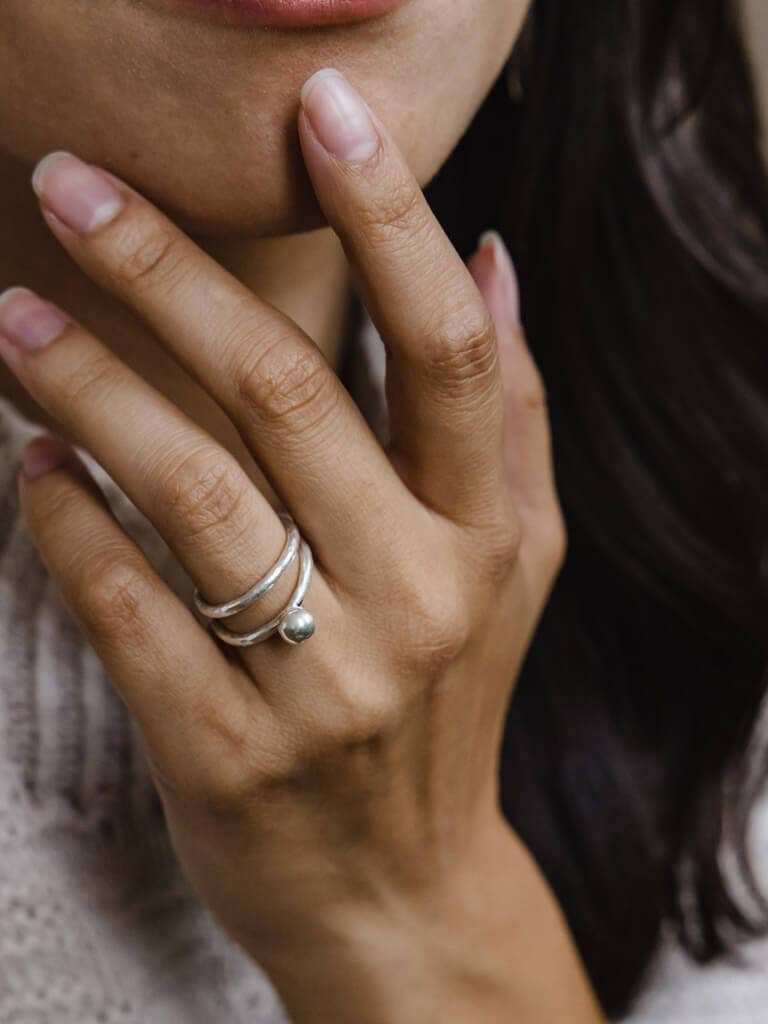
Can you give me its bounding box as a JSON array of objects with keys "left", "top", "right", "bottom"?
[{"left": 301, "top": 68, "right": 381, "bottom": 164}]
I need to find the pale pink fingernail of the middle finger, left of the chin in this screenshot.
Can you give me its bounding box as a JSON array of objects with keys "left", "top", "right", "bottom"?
[{"left": 32, "top": 153, "right": 124, "bottom": 234}]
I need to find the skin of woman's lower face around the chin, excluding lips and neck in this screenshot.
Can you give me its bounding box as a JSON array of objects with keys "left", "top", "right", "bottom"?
[{"left": 0, "top": 0, "right": 526, "bottom": 238}]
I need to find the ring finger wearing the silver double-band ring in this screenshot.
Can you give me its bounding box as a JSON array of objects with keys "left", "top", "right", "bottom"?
[{"left": 0, "top": 289, "right": 332, "bottom": 659}]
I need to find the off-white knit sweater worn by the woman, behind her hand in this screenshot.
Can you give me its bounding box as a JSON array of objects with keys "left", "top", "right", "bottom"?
[{"left": 0, "top": 315, "right": 768, "bottom": 1024}]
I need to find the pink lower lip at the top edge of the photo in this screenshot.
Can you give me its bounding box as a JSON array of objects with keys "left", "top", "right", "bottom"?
[{"left": 176, "top": 0, "right": 406, "bottom": 29}]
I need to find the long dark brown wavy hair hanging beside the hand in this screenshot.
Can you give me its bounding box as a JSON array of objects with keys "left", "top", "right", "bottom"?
[{"left": 427, "top": 0, "right": 768, "bottom": 1016}]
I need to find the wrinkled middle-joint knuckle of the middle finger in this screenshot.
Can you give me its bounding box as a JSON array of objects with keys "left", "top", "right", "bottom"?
[{"left": 237, "top": 345, "right": 339, "bottom": 434}]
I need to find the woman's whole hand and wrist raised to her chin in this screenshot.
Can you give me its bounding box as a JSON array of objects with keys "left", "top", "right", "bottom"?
[{"left": 0, "top": 73, "right": 597, "bottom": 1024}]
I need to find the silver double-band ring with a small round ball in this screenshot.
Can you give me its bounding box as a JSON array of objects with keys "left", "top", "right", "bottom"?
[{"left": 195, "top": 512, "right": 315, "bottom": 647}]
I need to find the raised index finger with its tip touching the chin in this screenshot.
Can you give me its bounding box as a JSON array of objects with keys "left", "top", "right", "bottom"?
[{"left": 299, "top": 68, "right": 504, "bottom": 520}]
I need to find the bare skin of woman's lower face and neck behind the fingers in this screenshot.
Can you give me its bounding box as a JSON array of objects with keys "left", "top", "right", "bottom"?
[{"left": 0, "top": 0, "right": 527, "bottom": 471}]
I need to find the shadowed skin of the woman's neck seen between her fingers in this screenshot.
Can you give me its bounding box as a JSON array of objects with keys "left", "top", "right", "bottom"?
[{"left": 0, "top": 151, "right": 349, "bottom": 458}]
